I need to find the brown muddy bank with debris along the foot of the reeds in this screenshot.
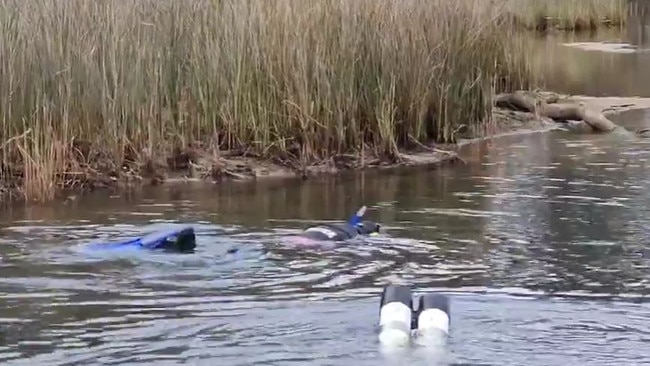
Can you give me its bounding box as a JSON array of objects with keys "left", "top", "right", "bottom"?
[{"left": 1, "top": 93, "right": 650, "bottom": 199}]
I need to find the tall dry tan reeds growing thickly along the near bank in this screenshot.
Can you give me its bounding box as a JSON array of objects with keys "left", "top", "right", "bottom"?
[{"left": 0, "top": 0, "right": 624, "bottom": 200}]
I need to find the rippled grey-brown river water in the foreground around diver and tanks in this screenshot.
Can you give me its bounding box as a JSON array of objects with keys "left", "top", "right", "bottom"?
[{"left": 0, "top": 24, "right": 650, "bottom": 366}]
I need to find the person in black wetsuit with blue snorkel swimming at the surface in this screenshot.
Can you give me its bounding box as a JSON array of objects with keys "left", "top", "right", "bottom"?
[{"left": 298, "top": 206, "right": 381, "bottom": 241}]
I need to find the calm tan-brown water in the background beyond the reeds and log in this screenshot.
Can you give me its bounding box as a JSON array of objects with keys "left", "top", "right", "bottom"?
[{"left": 522, "top": 5, "right": 650, "bottom": 97}]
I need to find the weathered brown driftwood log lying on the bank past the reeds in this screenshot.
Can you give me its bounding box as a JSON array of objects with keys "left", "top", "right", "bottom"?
[{"left": 496, "top": 90, "right": 622, "bottom": 133}]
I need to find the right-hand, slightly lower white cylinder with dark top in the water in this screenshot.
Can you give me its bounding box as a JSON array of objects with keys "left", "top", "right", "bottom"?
[{"left": 415, "top": 294, "right": 450, "bottom": 346}]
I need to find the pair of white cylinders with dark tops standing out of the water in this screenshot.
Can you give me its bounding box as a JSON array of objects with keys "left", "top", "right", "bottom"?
[{"left": 379, "top": 285, "right": 450, "bottom": 347}]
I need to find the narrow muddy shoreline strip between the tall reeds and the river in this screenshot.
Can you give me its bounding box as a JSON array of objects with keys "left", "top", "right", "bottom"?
[{"left": 2, "top": 90, "right": 650, "bottom": 201}]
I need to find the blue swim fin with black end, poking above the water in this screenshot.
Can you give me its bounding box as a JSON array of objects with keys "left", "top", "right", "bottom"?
[{"left": 86, "top": 226, "right": 196, "bottom": 253}]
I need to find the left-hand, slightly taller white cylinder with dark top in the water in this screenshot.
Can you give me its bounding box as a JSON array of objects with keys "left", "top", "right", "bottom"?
[{"left": 379, "top": 285, "right": 413, "bottom": 347}]
